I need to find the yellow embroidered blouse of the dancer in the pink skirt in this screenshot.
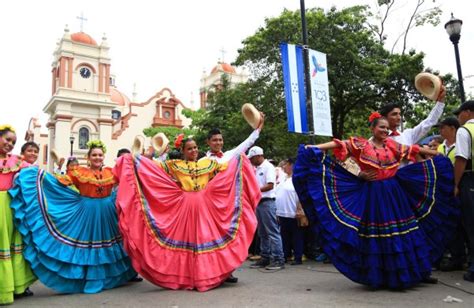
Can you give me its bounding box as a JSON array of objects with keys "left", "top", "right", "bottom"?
[{"left": 158, "top": 158, "right": 227, "bottom": 191}]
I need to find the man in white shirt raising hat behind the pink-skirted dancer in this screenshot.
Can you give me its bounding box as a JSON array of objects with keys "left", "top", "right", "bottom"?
[{"left": 206, "top": 114, "right": 264, "bottom": 163}]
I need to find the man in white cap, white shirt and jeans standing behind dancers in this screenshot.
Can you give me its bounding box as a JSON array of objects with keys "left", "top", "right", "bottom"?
[{"left": 247, "top": 146, "right": 285, "bottom": 270}]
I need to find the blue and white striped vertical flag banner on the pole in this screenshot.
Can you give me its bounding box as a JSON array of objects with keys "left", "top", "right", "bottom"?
[{"left": 280, "top": 43, "right": 309, "bottom": 133}]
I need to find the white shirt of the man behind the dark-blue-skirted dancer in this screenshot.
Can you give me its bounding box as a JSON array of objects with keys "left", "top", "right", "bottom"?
[{"left": 389, "top": 102, "right": 444, "bottom": 145}]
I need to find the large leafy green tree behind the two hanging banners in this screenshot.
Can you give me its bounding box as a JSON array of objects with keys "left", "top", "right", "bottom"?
[{"left": 236, "top": 6, "right": 423, "bottom": 137}]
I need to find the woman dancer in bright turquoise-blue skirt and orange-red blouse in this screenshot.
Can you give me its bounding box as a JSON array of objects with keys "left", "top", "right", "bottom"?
[{"left": 10, "top": 140, "right": 136, "bottom": 293}]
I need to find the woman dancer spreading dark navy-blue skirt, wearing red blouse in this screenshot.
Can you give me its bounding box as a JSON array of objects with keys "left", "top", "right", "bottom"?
[{"left": 293, "top": 113, "right": 458, "bottom": 288}]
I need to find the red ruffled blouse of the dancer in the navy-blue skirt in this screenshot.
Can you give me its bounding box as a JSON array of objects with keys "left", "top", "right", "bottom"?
[{"left": 334, "top": 137, "right": 420, "bottom": 180}]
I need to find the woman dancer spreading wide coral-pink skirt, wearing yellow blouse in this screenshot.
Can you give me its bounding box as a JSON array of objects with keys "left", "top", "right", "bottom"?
[{"left": 114, "top": 138, "right": 260, "bottom": 291}]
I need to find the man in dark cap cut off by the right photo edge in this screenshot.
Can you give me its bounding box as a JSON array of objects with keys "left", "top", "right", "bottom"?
[{"left": 454, "top": 100, "right": 474, "bottom": 282}]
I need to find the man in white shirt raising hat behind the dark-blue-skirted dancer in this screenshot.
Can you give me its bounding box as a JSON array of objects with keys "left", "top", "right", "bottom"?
[{"left": 379, "top": 86, "right": 446, "bottom": 145}]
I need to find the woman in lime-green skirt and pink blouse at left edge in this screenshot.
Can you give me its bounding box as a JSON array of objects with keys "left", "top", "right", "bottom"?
[{"left": 0, "top": 125, "right": 36, "bottom": 305}]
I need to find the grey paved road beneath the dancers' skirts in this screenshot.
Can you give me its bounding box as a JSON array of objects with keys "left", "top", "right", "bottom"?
[{"left": 14, "top": 262, "right": 474, "bottom": 308}]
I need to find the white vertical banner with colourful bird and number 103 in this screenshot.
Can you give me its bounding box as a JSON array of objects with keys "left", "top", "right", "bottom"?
[{"left": 308, "top": 49, "right": 332, "bottom": 137}]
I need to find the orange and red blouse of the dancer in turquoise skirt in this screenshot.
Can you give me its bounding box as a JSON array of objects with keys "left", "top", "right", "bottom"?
[{"left": 57, "top": 166, "right": 116, "bottom": 198}]
